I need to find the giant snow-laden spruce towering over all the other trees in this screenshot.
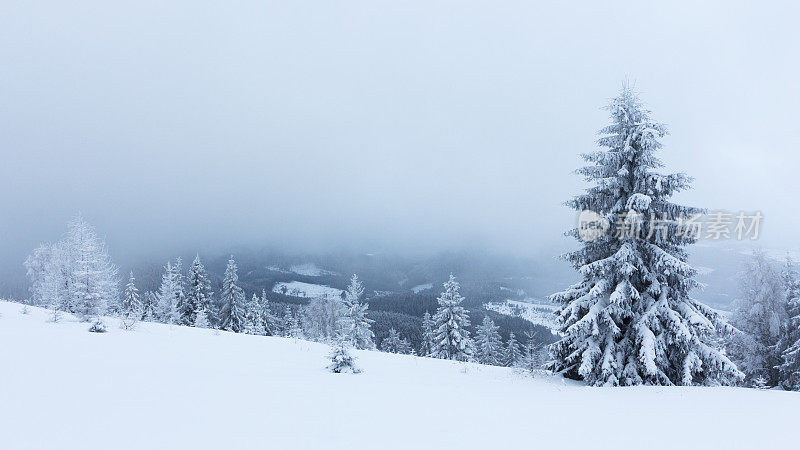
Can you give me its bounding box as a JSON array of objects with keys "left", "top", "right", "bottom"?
[{"left": 548, "top": 87, "right": 741, "bottom": 386}]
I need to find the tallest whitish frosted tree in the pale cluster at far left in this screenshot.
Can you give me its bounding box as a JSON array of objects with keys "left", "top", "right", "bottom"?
[{"left": 65, "top": 215, "right": 119, "bottom": 320}]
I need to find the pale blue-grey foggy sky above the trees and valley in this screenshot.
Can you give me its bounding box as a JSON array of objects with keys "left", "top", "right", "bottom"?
[{"left": 0, "top": 0, "right": 800, "bottom": 270}]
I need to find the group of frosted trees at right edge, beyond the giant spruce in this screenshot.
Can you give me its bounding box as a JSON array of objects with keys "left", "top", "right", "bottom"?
[{"left": 726, "top": 251, "right": 800, "bottom": 390}]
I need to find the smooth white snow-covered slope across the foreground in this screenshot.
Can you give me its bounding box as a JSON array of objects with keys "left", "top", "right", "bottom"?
[{"left": 0, "top": 302, "right": 800, "bottom": 450}]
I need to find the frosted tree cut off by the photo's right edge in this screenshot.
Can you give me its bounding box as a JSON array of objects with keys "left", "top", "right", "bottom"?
[{"left": 778, "top": 258, "right": 800, "bottom": 391}]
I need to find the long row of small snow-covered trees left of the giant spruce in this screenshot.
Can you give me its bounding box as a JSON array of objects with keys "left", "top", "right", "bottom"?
[{"left": 25, "top": 224, "right": 537, "bottom": 366}]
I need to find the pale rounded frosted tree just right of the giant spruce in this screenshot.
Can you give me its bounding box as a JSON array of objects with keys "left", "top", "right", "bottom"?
[{"left": 728, "top": 251, "right": 787, "bottom": 386}]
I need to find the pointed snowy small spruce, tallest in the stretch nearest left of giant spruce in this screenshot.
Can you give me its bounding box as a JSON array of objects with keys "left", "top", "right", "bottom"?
[{"left": 431, "top": 273, "right": 474, "bottom": 361}]
